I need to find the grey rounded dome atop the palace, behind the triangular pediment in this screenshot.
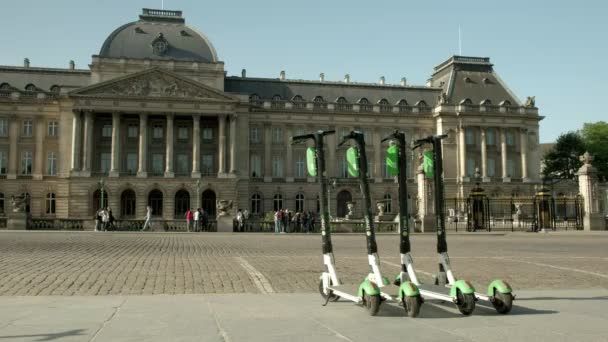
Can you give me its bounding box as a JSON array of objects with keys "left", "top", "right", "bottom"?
[{"left": 99, "top": 8, "right": 217, "bottom": 63}]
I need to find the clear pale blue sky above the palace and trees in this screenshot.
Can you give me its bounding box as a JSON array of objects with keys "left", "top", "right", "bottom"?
[{"left": 0, "top": 0, "right": 608, "bottom": 142}]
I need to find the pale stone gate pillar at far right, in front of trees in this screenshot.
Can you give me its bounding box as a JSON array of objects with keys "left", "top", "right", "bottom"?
[{"left": 577, "top": 152, "right": 606, "bottom": 231}]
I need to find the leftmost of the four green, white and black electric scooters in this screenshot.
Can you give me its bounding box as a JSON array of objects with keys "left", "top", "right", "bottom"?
[{"left": 292, "top": 130, "right": 382, "bottom": 316}]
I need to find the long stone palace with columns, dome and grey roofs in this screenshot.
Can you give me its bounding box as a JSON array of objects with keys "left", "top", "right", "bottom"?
[{"left": 0, "top": 9, "right": 543, "bottom": 224}]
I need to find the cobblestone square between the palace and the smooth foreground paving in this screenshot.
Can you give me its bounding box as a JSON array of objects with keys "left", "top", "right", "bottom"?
[{"left": 0, "top": 231, "right": 608, "bottom": 296}]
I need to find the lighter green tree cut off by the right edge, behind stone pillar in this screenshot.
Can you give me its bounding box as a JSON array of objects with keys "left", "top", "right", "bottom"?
[{"left": 580, "top": 121, "right": 608, "bottom": 181}]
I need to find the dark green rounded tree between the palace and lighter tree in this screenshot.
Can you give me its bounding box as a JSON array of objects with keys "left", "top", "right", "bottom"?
[{"left": 543, "top": 131, "right": 586, "bottom": 179}]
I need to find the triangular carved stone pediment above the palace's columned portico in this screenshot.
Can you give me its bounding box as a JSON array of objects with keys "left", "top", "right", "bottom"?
[{"left": 70, "top": 68, "right": 237, "bottom": 102}]
